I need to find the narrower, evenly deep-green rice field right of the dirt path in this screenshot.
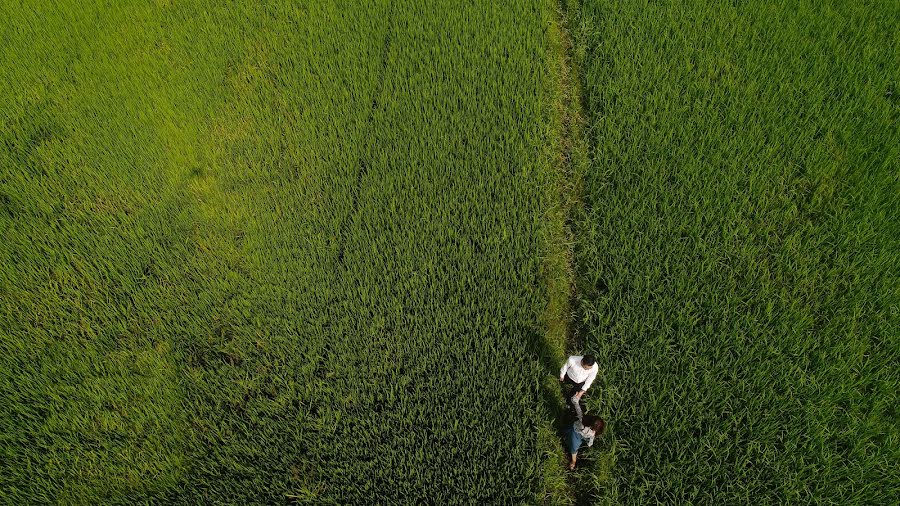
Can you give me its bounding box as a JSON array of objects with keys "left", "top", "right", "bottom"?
[{"left": 573, "top": 0, "right": 900, "bottom": 504}]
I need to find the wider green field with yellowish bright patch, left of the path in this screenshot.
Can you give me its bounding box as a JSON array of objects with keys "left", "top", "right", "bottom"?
[{"left": 0, "top": 0, "right": 567, "bottom": 504}]
